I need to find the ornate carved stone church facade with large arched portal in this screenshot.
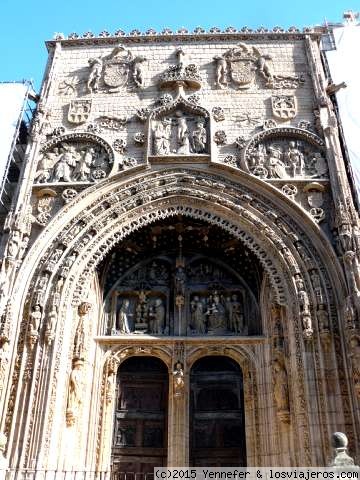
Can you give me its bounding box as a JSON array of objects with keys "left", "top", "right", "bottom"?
[{"left": 0, "top": 24, "right": 360, "bottom": 474}]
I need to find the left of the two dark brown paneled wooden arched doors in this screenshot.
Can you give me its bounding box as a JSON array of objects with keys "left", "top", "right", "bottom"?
[{"left": 111, "top": 356, "right": 169, "bottom": 474}]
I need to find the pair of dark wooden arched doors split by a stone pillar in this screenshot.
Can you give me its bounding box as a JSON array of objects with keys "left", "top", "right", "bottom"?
[{"left": 112, "top": 356, "right": 246, "bottom": 470}]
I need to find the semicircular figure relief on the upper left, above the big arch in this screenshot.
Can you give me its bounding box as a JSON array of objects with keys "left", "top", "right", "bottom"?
[{"left": 35, "top": 135, "right": 112, "bottom": 183}]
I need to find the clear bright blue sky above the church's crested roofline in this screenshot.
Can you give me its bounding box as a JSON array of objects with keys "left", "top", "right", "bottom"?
[{"left": 0, "top": 0, "right": 360, "bottom": 90}]
